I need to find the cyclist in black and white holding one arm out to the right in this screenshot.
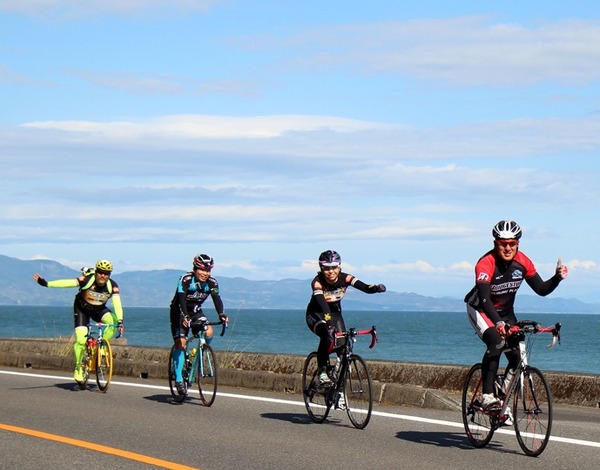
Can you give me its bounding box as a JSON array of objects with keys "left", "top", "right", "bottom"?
[{"left": 306, "top": 250, "right": 385, "bottom": 384}]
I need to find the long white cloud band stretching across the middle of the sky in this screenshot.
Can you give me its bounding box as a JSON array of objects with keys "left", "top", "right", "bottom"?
[{"left": 14, "top": 115, "right": 600, "bottom": 162}]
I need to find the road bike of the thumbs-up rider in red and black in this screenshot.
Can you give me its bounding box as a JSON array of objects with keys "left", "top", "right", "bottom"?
[{"left": 462, "top": 320, "right": 561, "bottom": 457}]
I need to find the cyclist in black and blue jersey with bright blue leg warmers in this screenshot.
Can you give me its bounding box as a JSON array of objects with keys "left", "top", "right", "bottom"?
[{"left": 170, "top": 254, "right": 229, "bottom": 395}]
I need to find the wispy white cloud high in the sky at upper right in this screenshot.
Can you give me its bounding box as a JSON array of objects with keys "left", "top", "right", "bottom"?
[{"left": 255, "top": 16, "right": 600, "bottom": 87}]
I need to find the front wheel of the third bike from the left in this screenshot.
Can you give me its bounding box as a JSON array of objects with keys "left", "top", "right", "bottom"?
[{"left": 341, "top": 354, "right": 373, "bottom": 429}]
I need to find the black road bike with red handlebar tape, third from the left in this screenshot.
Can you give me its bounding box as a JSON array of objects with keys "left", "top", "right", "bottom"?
[{"left": 302, "top": 326, "right": 377, "bottom": 429}]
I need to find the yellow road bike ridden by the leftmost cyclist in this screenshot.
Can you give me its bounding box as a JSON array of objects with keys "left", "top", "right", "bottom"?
[{"left": 77, "top": 322, "right": 120, "bottom": 393}]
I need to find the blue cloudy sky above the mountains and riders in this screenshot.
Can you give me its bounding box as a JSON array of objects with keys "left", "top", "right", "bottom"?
[{"left": 0, "top": 0, "right": 600, "bottom": 302}]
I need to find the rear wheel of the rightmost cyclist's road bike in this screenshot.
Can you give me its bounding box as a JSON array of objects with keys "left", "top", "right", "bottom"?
[{"left": 462, "top": 364, "right": 494, "bottom": 448}]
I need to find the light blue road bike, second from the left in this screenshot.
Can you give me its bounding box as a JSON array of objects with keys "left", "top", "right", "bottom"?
[{"left": 169, "top": 319, "right": 227, "bottom": 406}]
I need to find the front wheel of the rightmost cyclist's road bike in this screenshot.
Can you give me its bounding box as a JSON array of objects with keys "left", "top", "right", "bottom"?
[{"left": 513, "top": 367, "right": 552, "bottom": 457}]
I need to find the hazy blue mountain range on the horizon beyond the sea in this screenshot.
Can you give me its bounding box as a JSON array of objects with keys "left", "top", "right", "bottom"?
[{"left": 0, "top": 255, "right": 600, "bottom": 313}]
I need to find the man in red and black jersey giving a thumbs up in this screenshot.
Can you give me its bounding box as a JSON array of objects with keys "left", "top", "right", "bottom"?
[{"left": 465, "top": 220, "right": 568, "bottom": 407}]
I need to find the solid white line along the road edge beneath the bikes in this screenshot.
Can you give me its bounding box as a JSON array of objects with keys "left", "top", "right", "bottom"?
[{"left": 0, "top": 370, "right": 600, "bottom": 448}]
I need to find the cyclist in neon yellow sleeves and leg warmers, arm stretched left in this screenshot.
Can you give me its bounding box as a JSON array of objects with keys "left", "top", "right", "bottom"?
[{"left": 33, "top": 260, "right": 125, "bottom": 382}]
